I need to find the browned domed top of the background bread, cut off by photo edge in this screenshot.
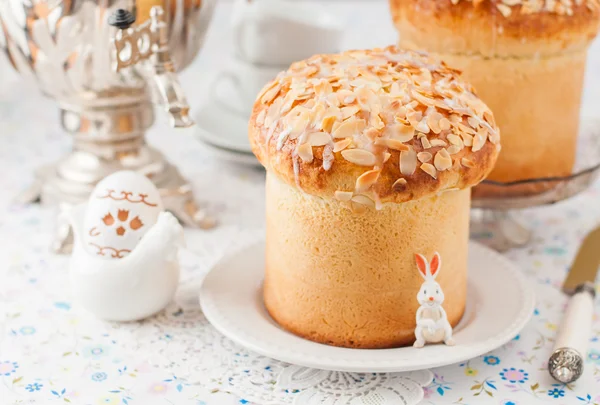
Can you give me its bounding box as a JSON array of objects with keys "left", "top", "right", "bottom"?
[{"left": 390, "top": 0, "right": 600, "bottom": 57}]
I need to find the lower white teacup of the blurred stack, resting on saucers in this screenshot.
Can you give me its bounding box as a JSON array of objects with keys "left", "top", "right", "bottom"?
[{"left": 211, "top": 60, "right": 287, "bottom": 118}]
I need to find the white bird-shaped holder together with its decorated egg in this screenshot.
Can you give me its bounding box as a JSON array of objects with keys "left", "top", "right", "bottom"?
[{"left": 66, "top": 171, "right": 184, "bottom": 321}]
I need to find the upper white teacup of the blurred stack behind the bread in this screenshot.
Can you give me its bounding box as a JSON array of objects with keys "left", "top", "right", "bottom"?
[{"left": 232, "top": 0, "right": 343, "bottom": 66}]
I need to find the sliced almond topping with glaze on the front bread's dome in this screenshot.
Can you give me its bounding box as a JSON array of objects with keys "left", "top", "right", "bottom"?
[{"left": 254, "top": 46, "right": 502, "bottom": 183}]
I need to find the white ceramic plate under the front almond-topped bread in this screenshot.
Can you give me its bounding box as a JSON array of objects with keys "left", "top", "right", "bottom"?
[{"left": 200, "top": 241, "right": 535, "bottom": 372}]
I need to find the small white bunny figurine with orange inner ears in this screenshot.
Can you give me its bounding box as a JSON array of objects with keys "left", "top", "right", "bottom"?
[{"left": 413, "top": 252, "right": 454, "bottom": 347}]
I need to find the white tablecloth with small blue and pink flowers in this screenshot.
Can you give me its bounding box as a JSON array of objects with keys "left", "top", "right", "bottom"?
[{"left": 0, "top": 3, "right": 600, "bottom": 405}]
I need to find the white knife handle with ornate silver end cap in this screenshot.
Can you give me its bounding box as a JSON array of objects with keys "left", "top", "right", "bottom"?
[{"left": 548, "top": 284, "right": 595, "bottom": 384}]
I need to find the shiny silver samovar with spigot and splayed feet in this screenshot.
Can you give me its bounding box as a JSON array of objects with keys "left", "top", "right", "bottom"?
[{"left": 0, "top": 0, "right": 214, "bottom": 250}]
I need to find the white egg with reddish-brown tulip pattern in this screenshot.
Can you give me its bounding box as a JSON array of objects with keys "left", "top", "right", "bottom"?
[{"left": 83, "top": 171, "right": 163, "bottom": 259}]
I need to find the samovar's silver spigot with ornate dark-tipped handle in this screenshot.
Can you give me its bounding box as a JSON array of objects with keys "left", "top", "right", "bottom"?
[{"left": 108, "top": 6, "right": 194, "bottom": 128}]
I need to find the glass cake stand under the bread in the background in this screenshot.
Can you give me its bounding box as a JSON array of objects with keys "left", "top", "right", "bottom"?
[{"left": 471, "top": 110, "right": 600, "bottom": 252}]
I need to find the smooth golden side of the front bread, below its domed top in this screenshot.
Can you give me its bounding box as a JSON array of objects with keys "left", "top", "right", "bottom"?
[{"left": 263, "top": 173, "right": 471, "bottom": 348}]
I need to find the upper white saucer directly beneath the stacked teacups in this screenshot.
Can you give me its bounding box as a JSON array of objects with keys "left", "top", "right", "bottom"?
[{"left": 194, "top": 102, "right": 252, "bottom": 154}]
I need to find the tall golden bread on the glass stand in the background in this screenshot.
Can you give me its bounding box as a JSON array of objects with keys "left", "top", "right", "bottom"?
[{"left": 390, "top": 0, "right": 600, "bottom": 188}]
